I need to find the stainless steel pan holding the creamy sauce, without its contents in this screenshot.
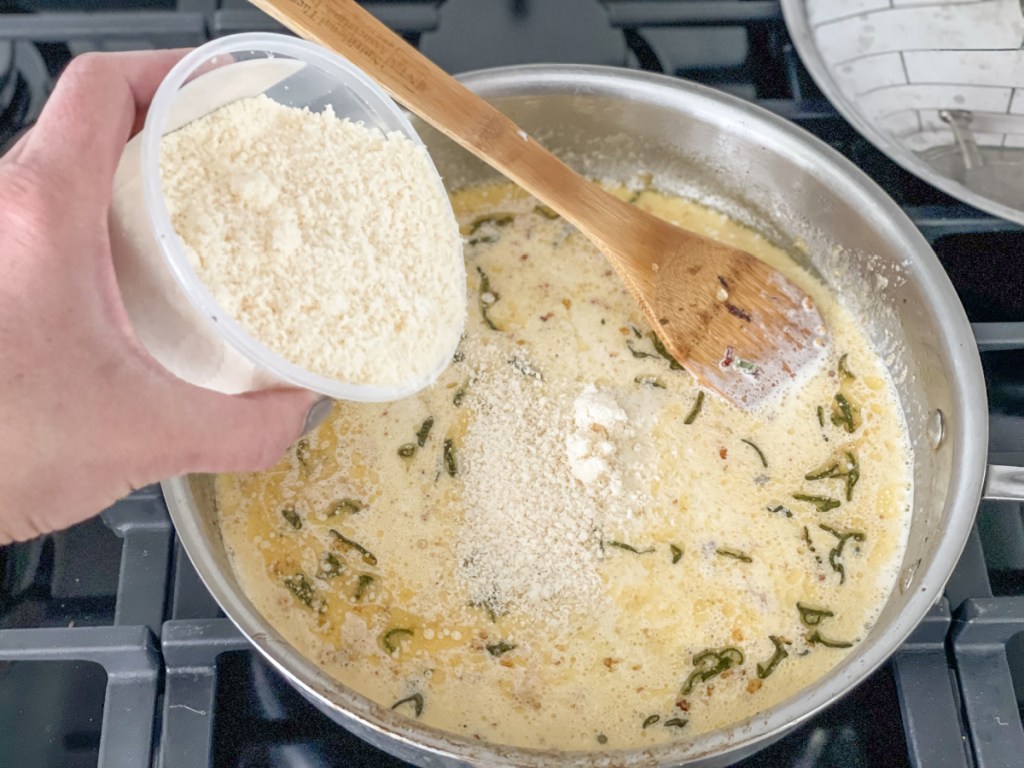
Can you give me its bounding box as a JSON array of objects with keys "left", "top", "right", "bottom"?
[{"left": 164, "top": 67, "right": 1024, "bottom": 766}]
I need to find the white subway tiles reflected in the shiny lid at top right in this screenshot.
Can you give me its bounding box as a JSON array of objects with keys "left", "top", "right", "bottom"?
[{"left": 807, "top": 0, "right": 1024, "bottom": 152}]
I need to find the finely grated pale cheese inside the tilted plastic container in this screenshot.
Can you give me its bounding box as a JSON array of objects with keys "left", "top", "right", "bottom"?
[{"left": 161, "top": 95, "right": 465, "bottom": 387}]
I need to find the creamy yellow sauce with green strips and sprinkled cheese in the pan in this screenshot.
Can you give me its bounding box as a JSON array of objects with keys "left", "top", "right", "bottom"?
[{"left": 217, "top": 184, "right": 911, "bottom": 750}]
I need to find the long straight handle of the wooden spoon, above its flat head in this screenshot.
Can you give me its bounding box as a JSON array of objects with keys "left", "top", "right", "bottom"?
[{"left": 245, "top": 0, "right": 633, "bottom": 259}]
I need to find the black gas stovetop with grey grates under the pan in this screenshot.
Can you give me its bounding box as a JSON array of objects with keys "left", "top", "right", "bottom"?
[{"left": 6, "top": 0, "right": 1024, "bottom": 768}]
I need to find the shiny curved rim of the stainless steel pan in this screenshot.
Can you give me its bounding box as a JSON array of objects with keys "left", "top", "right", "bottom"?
[{"left": 163, "top": 65, "right": 988, "bottom": 768}]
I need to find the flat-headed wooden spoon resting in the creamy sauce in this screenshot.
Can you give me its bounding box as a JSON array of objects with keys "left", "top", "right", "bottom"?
[{"left": 245, "top": 0, "right": 826, "bottom": 407}]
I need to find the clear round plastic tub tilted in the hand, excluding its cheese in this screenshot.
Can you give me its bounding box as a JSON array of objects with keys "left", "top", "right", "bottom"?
[{"left": 110, "top": 33, "right": 464, "bottom": 401}]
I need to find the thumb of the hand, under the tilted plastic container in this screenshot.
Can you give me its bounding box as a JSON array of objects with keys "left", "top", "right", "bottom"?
[{"left": 155, "top": 382, "right": 333, "bottom": 474}]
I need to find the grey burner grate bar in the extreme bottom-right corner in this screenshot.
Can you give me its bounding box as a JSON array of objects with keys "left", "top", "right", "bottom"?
[{"left": 952, "top": 596, "right": 1024, "bottom": 768}]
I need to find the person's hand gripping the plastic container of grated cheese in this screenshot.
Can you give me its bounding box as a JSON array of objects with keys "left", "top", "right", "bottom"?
[{"left": 0, "top": 51, "right": 327, "bottom": 544}]
